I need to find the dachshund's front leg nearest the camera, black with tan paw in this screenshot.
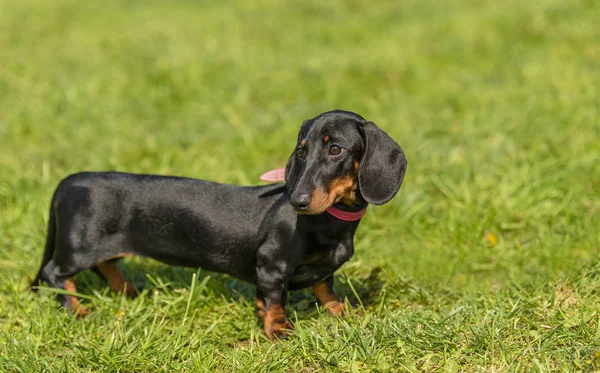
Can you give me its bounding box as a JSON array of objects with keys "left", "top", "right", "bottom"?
[{"left": 256, "top": 266, "right": 293, "bottom": 340}]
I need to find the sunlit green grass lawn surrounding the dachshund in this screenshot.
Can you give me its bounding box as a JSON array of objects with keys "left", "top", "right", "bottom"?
[{"left": 0, "top": 0, "right": 600, "bottom": 372}]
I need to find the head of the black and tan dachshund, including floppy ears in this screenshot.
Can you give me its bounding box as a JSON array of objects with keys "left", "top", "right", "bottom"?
[{"left": 285, "top": 110, "right": 407, "bottom": 215}]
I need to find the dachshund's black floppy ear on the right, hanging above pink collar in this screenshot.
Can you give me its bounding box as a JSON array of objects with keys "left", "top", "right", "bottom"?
[{"left": 358, "top": 122, "right": 407, "bottom": 205}]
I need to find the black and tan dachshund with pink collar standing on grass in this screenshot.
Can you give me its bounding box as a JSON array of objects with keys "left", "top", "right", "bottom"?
[{"left": 32, "top": 110, "right": 407, "bottom": 339}]
